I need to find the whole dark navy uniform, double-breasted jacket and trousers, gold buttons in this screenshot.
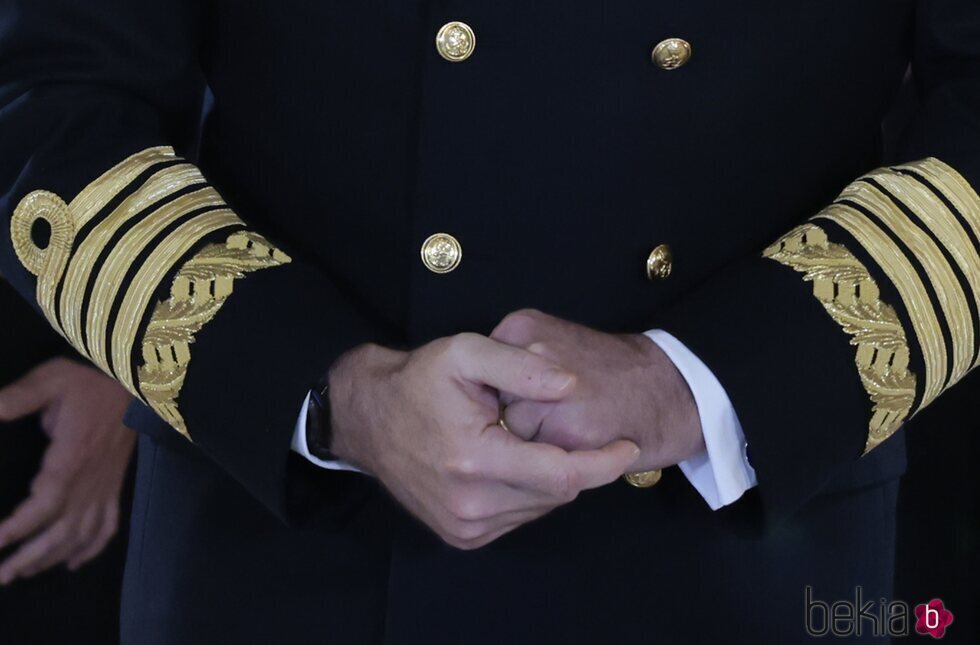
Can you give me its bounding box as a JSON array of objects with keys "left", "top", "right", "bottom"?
[{"left": 0, "top": 0, "right": 980, "bottom": 643}]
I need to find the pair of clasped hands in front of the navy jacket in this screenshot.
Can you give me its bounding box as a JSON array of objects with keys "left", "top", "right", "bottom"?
[{"left": 330, "top": 311, "right": 703, "bottom": 549}]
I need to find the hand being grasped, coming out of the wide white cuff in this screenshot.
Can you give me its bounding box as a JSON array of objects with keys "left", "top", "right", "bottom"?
[{"left": 491, "top": 310, "right": 705, "bottom": 471}]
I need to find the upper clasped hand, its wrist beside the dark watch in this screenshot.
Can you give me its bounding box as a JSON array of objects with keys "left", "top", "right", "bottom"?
[{"left": 330, "top": 334, "right": 639, "bottom": 549}]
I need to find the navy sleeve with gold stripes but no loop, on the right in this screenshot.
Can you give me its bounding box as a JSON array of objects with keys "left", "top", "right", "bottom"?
[{"left": 654, "top": 0, "right": 980, "bottom": 519}]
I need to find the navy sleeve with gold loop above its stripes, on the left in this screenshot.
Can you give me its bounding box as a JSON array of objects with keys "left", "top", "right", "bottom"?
[{"left": 0, "top": 0, "right": 394, "bottom": 513}]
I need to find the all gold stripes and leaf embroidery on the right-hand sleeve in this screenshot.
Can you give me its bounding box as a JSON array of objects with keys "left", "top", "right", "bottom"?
[{"left": 764, "top": 158, "right": 980, "bottom": 450}]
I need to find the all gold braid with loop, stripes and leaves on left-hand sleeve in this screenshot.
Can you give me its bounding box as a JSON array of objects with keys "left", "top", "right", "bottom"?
[{"left": 11, "top": 147, "right": 290, "bottom": 436}]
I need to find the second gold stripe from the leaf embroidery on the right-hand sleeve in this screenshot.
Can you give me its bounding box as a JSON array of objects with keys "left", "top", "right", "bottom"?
[{"left": 841, "top": 177, "right": 973, "bottom": 384}]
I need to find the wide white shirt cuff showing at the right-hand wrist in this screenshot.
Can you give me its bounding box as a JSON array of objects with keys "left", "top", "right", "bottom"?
[{"left": 646, "top": 329, "right": 758, "bottom": 511}]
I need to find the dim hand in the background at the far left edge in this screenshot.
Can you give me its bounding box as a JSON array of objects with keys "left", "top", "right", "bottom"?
[{"left": 0, "top": 358, "right": 136, "bottom": 585}]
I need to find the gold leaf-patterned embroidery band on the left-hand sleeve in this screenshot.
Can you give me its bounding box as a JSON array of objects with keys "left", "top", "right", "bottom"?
[{"left": 139, "top": 233, "right": 290, "bottom": 438}]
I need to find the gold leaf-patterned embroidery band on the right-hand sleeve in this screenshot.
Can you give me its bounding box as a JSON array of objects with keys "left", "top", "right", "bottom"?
[{"left": 763, "top": 224, "right": 916, "bottom": 452}]
